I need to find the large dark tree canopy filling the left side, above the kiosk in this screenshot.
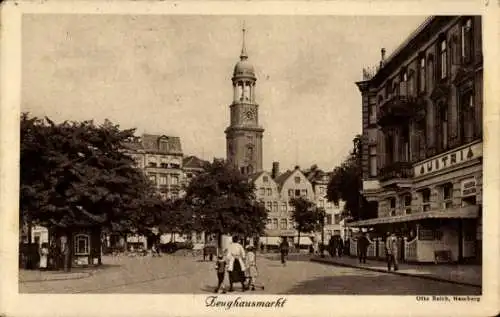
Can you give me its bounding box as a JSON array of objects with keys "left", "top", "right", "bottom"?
[{"left": 20, "top": 113, "right": 162, "bottom": 232}]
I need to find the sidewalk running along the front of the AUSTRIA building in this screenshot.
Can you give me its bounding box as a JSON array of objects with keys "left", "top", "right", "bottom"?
[{"left": 311, "top": 255, "right": 482, "bottom": 287}]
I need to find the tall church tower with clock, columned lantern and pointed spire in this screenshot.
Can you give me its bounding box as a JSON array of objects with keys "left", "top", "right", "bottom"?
[{"left": 225, "top": 27, "right": 264, "bottom": 175}]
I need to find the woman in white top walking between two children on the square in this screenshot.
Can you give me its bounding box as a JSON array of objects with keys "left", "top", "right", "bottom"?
[{"left": 215, "top": 236, "right": 263, "bottom": 293}]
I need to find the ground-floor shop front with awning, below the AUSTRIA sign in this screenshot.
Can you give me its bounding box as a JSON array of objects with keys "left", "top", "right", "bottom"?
[{"left": 350, "top": 206, "right": 479, "bottom": 263}]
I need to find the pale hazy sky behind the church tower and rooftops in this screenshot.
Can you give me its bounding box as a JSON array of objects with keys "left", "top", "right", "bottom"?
[{"left": 21, "top": 14, "right": 425, "bottom": 171}]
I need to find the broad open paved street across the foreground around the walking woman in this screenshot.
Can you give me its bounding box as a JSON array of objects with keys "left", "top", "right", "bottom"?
[{"left": 19, "top": 255, "right": 480, "bottom": 295}]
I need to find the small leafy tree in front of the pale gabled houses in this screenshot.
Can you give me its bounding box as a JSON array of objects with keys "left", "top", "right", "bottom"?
[{"left": 290, "top": 197, "right": 325, "bottom": 248}]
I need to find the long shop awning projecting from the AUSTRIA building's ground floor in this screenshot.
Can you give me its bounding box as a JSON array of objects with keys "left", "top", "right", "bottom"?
[{"left": 347, "top": 205, "right": 479, "bottom": 227}]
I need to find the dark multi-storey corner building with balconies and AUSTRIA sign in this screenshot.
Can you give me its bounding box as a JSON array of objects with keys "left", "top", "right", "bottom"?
[{"left": 351, "top": 16, "right": 483, "bottom": 262}]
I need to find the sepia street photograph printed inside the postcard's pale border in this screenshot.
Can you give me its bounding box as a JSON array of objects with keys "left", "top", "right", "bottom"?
[{"left": 2, "top": 0, "right": 498, "bottom": 316}]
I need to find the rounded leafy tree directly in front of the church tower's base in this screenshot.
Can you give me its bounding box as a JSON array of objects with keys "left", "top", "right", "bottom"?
[{"left": 184, "top": 161, "right": 267, "bottom": 246}]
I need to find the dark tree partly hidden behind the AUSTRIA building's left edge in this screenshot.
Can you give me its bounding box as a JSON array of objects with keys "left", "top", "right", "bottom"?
[{"left": 327, "top": 135, "right": 376, "bottom": 220}]
